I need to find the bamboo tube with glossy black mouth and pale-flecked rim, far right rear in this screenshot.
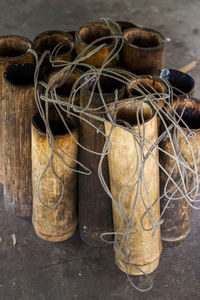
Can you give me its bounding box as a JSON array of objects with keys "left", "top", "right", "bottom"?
[{"left": 161, "top": 69, "right": 195, "bottom": 99}]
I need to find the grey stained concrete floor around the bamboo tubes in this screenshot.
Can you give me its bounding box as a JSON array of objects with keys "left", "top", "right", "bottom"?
[{"left": 0, "top": 0, "right": 200, "bottom": 300}]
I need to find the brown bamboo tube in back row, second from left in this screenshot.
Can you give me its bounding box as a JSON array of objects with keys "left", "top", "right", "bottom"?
[{"left": 33, "top": 30, "right": 75, "bottom": 74}]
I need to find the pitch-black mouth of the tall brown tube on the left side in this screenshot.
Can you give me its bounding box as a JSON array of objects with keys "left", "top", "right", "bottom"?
[{"left": 4, "top": 63, "right": 45, "bottom": 86}]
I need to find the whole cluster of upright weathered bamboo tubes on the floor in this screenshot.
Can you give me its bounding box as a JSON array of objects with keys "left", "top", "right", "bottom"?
[{"left": 0, "top": 21, "right": 200, "bottom": 290}]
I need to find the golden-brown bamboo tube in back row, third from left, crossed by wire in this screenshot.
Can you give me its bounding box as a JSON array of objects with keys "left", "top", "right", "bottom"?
[{"left": 76, "top": 22, "right": 117, "bottom": 68}]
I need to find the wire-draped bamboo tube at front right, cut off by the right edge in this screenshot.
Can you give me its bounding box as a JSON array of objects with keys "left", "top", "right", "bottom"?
[{"left": 160, "top": 98, "right": 200, "bottom": 247}]
